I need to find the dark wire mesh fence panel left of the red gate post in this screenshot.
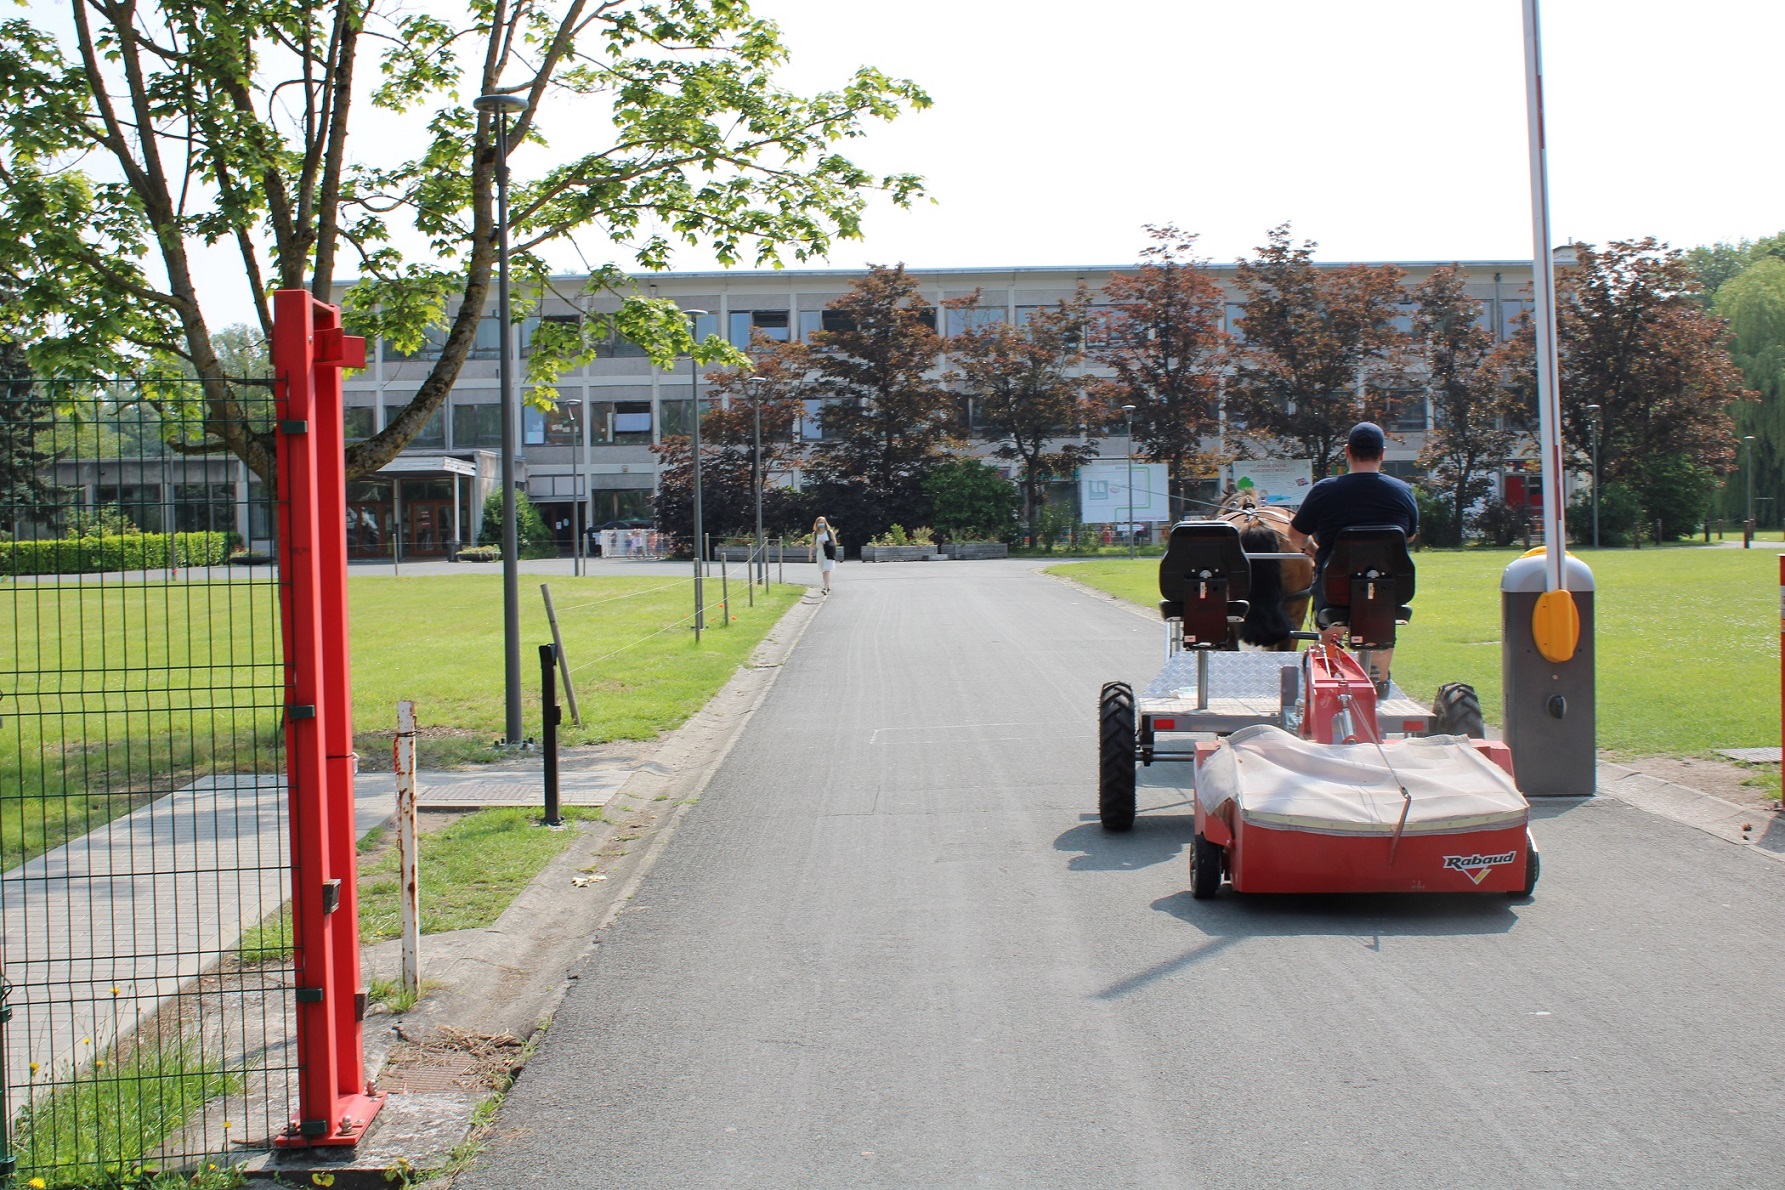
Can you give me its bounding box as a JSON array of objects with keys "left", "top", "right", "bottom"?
[{"left": 0, "top": 380, "right": 296, "bottom": 1186}]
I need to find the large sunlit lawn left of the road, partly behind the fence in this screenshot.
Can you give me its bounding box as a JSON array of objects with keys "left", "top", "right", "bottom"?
[{"left": 0, "top": 573, "right": 801, "bottom": 867}]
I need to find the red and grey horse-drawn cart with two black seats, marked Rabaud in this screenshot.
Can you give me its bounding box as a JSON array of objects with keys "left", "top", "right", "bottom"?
[{"left": 1098, "top": 521, "right": 1539, "bottom": 897}]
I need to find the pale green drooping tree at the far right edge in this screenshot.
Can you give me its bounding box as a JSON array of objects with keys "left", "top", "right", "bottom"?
[{"left": 1715, "top": 257, "right": 1785, "bottom": 519}]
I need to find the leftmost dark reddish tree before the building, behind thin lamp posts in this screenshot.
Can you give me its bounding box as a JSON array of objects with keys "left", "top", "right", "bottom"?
[{"left": 652, "top": 332, "right": 807, "bottom": 550}]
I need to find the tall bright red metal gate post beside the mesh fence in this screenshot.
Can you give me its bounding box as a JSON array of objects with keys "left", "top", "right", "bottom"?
[{"left": 273, "top": 289, "right": 384, "bottom": 1147}]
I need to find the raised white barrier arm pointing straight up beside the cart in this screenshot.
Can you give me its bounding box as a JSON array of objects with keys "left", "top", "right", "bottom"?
[{"left": 1523, "top": 0, "right": 1567, "bottom": 591}]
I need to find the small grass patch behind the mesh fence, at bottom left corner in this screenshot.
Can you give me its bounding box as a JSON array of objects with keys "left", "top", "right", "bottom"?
[{"left": 12, "top": 1044, "right": 241, "bottom": 1186}]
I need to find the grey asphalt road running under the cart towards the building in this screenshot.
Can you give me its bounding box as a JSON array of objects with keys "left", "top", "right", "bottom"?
[{"left": 461, "top": 562, "right": 1785, "bottom": 1188}]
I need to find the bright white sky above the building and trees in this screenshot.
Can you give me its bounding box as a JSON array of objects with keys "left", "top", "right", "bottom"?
[{"left": 139, "top": 0, "right": 1785, "bottom": 310}]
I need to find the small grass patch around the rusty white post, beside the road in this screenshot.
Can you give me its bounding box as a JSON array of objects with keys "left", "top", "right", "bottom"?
[{"left": 359, "top": 806, "right": 600, "bottom": 944}]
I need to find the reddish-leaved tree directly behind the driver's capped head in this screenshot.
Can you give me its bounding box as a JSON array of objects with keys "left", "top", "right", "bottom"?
[{"left": 1226, "top": 223, "right": 1405, "bottom": 478}]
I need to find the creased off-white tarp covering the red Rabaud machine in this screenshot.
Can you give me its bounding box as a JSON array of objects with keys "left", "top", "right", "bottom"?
[{"left": 1196, "top": 724, "right": 1530, "bottom": 835}]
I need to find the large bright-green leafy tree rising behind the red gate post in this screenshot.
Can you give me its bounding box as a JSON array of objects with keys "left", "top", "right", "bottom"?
[{"left": 0, "top": 0, "right": 928, "bottom": 478}]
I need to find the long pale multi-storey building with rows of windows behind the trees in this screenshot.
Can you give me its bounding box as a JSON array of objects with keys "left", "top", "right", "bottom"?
[{"left": 332, "top": 260, "right": 1535, "bottom": 557}]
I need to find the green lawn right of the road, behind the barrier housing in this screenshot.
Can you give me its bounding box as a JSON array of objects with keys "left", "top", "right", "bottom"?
[{"left": 1050, "top": 546, "right": 1780, "bottom": 756}]
